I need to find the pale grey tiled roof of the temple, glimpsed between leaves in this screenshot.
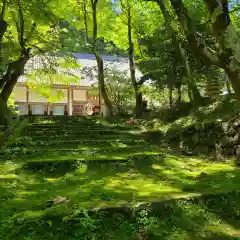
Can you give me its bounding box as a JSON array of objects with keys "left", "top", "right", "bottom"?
[{"left": 18, "top": 53, "right": 142, "bottom": 87}]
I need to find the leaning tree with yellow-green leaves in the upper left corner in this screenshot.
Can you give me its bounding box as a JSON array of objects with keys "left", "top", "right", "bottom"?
[{"left": 0, "top": 0, "right": 67, "bottom": 102}]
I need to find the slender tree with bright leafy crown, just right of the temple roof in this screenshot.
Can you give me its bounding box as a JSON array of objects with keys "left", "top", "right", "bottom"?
[{"left": 108, "top": 0, "right": 160, "bottom": 117}]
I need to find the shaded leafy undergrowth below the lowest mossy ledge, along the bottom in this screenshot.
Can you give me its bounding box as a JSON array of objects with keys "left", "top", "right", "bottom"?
[{"left": 0, "top": 192, "right": 240, "bottom": 240}]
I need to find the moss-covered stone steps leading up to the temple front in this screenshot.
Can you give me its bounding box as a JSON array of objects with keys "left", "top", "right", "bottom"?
[{"left": 6, "top": 117, "right": 151, "bottom": 162}]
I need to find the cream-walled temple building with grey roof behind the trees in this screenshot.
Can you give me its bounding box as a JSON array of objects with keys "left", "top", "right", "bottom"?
[{"left": 13, "top": 53, "right": 129, "bottom": 116}]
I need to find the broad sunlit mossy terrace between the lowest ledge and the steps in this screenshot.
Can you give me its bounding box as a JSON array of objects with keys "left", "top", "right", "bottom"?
[{"left": 0, "top": 152, "right": 240, "bottom": 214}]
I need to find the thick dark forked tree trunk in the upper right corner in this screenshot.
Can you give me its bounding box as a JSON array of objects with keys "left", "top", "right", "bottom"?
[{"left": 170, "top": 0, "right": 240, "bottom": 98}]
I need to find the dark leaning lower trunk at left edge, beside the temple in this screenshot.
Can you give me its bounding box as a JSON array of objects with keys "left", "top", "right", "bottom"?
[{"left": 0, "top": 54, "right": 30, "bottom": 102}]
